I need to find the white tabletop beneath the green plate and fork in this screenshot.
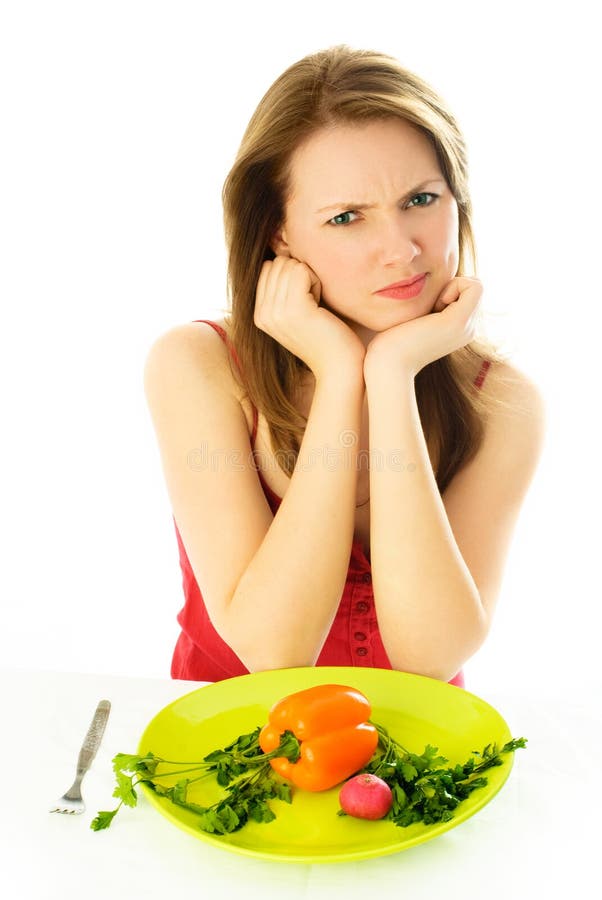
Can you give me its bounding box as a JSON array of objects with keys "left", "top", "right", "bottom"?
[{"left": 0, "top": 670, "right": 602, "bottom": 900}]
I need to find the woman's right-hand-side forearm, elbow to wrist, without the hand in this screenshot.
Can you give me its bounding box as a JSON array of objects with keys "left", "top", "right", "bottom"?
[{"left": 366, "top": 373, "right": 485, "bottom": 680}]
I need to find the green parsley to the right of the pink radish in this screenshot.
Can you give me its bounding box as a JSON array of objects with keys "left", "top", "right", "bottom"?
[{"left": 358, "top": 723, "right": 527, "bottom": 828}]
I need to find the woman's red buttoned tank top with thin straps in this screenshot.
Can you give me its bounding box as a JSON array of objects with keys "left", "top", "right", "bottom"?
[{"left": 171, "top": 319, "right": 490, "bottom": 687}]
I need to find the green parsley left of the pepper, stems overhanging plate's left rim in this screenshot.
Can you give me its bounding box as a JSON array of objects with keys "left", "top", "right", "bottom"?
[{"left": 90, "top": 726, "right": 300, "bottom": 834}]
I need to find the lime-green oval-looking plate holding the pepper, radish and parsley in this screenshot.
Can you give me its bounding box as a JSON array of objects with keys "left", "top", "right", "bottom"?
[{"left": 138, "top": 666, "right": 513, "bottom": 863}]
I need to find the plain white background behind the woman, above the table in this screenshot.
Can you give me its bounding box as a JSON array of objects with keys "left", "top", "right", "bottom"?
[{"left": 0, "top": 0, "right": 602, "bottom": 696}]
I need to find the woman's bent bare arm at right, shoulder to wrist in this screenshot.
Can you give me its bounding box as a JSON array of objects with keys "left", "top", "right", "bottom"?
[{"left": 367, "top": 362, "right": 544, "bottom": 681}]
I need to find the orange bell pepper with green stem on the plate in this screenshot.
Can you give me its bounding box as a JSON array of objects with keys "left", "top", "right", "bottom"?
[{"left": 259, "top": 684, "right": 378, "bottom": 791}]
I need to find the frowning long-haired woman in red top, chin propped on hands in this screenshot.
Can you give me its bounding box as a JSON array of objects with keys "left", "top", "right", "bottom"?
[{"left": 145, "top": 46, "right": 543, "bottom": 685}]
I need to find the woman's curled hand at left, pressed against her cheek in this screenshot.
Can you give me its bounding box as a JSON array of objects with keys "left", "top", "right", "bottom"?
[{"left": 254, "top": 256, "right": 366, "bottom": 378}]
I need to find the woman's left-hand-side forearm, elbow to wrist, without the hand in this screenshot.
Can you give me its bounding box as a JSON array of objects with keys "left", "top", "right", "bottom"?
[{"left": 224, "top": 368, "right": 364, "bottom": 670}]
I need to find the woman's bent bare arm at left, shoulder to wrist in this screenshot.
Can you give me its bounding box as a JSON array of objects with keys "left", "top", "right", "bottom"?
[{"left": 145, "top": 325, "right": 364, "bottom": 671}]
